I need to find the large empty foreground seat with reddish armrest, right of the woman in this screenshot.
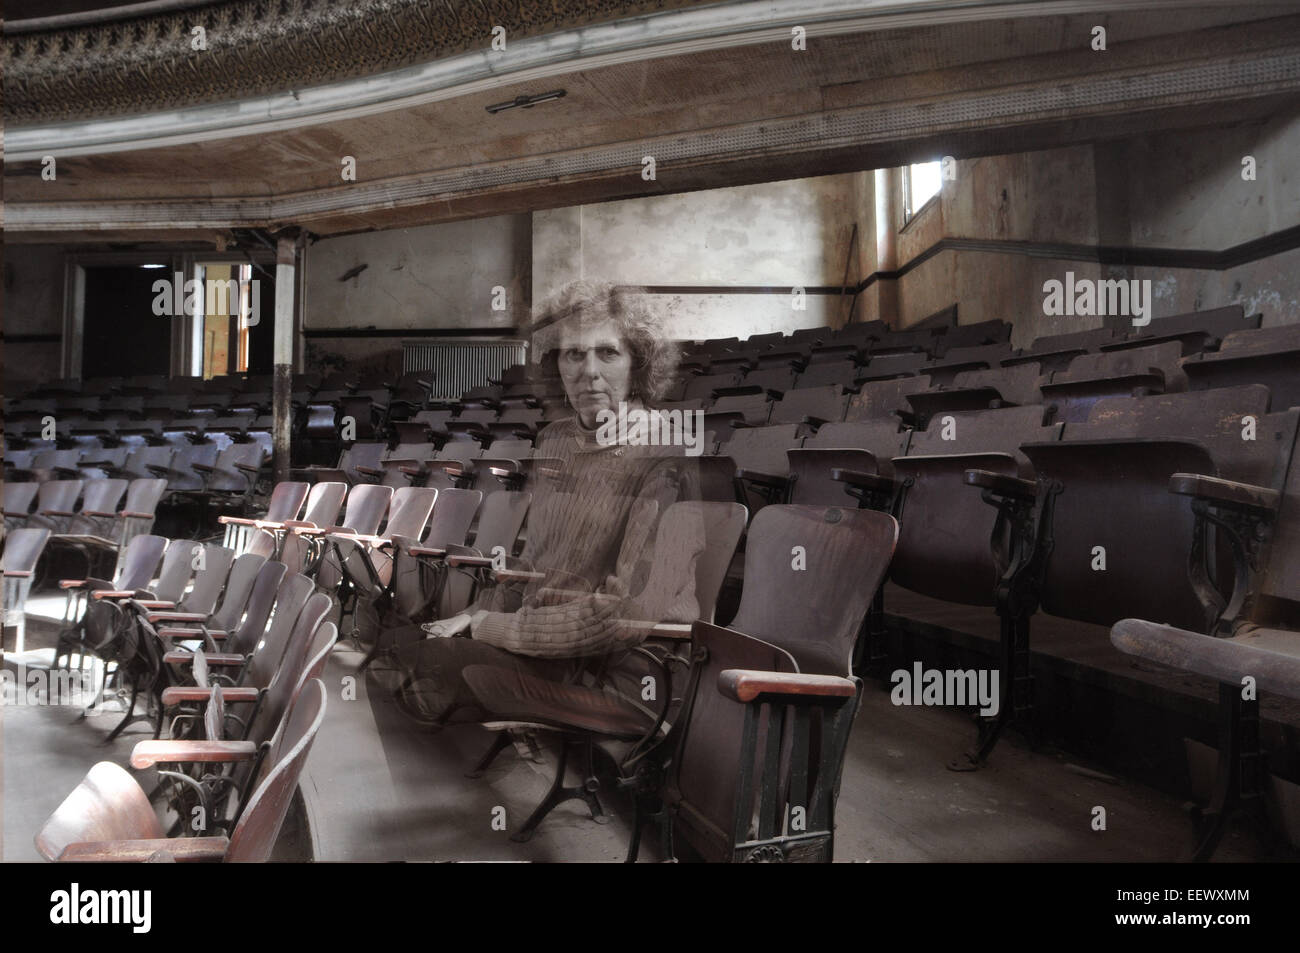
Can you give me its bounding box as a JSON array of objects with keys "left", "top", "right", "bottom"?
[{"left": 655, "top": 506, "right": 897, "bottom": 862}]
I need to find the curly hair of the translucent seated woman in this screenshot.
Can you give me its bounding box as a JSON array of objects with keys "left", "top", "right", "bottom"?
[{"left": 533, "top": 281, "right": 680, "bottom": 402}]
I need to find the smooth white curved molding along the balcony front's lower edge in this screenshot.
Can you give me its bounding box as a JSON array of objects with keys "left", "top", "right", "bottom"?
[{"left": 4, "top": 0, "right": 1248, "bottom": 161}]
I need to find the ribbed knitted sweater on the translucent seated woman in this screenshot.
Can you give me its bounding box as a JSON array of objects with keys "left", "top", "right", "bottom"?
[{"left": 472, "top": 419, "right": 705, "bottom": 658}]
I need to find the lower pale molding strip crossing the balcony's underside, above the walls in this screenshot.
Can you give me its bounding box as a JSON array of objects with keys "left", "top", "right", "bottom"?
[{"left": 5, "top": 47, "right": 1300, "bottom": 233}]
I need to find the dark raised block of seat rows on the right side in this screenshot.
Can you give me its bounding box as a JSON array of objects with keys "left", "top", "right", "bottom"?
[{"left": 670, "top": 312, "right": 1300, "bottom": 858}]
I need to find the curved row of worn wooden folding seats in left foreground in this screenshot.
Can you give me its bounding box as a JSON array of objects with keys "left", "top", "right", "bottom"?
[{"left": 36, "top": 534, "right": 337, "bottom": 862}]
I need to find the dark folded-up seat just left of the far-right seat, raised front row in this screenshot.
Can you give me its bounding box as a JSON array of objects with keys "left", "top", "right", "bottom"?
[{"left": 967, "top": 385, "right": 1300, "bottom": 764}]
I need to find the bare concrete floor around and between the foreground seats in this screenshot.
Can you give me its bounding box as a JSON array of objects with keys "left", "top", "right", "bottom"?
[{"left": 0, "top": 598, "right": 1260, "bottom": 862}]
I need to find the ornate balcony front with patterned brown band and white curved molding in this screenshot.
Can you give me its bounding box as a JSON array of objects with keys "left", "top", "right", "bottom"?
[{"left": 3, "top": 0, "right": 1253, "bottom": 134}]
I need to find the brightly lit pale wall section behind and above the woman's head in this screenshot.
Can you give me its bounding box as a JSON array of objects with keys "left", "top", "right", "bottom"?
[{"left": 533, "top": 173, "right": 872, "bottom": 338}]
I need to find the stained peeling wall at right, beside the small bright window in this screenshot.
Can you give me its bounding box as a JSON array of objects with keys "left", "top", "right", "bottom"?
[{"left": 883, "top": 121, "right": 1300, "bottom": 346}]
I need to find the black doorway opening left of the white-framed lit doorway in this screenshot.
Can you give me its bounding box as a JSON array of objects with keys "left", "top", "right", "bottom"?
[{"left": 82, "top": 265, "right": 174, "bottom": 378}]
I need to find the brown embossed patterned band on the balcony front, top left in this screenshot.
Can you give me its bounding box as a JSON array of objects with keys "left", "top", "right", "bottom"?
[{"left": 4, "top": 0, "right": 709, "bottom": 125}]
